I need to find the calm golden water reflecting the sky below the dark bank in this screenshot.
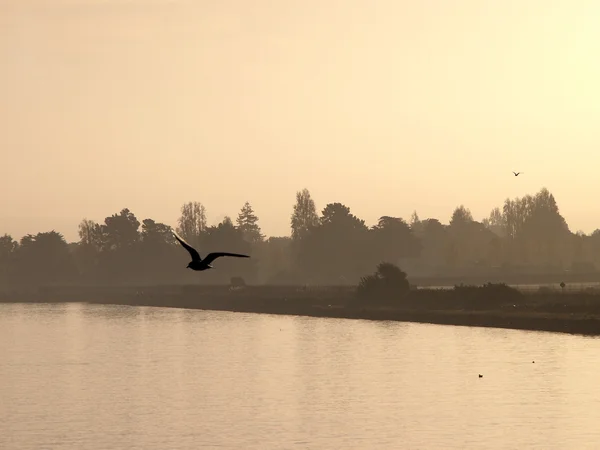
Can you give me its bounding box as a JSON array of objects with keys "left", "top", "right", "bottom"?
[{"left": 0, "top": 304, "right": 600, "bottom": 450}]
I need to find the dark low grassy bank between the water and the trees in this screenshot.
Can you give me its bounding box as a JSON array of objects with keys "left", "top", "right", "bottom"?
[{"left": 0, "top": 286, "right": 600, "bottom": 335}]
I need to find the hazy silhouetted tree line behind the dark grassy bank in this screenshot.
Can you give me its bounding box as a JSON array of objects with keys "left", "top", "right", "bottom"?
[{"left": 0, "top": 188, "right": 600, "bottom": 288}]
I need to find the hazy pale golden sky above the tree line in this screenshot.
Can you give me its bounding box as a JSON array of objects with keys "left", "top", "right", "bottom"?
[{"left": 0, "top": 0, "right": 600, "bottom": 240}]
